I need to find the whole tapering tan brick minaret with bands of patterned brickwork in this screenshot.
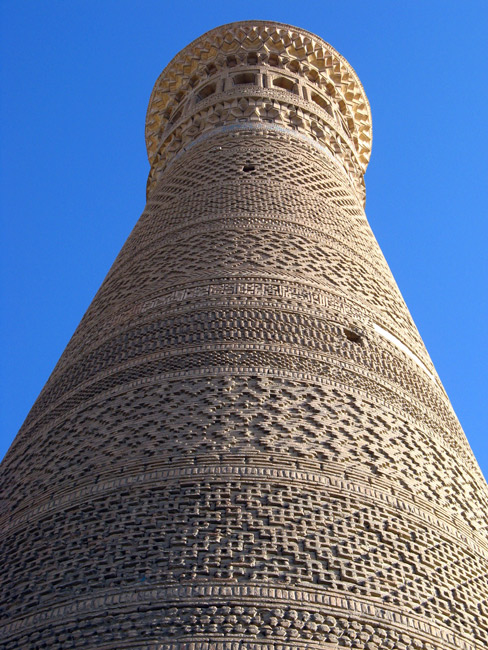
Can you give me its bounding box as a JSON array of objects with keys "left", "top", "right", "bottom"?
[{"left": 0, "top": 21, "right": 488, "bottom": 650}]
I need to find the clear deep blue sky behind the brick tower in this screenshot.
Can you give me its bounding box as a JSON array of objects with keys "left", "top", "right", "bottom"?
[{"left": 0, "top": 0, "right": 488, "bottom": 476}]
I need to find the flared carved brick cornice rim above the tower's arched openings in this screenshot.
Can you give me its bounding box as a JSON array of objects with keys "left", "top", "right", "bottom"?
[{"left": 146, "top": 20, "right": 372, "bottom": 173}]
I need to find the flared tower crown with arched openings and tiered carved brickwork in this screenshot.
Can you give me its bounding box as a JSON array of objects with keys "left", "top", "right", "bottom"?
[{"left": 146, "top": 21, "right": 372, "bottom": 200}]
